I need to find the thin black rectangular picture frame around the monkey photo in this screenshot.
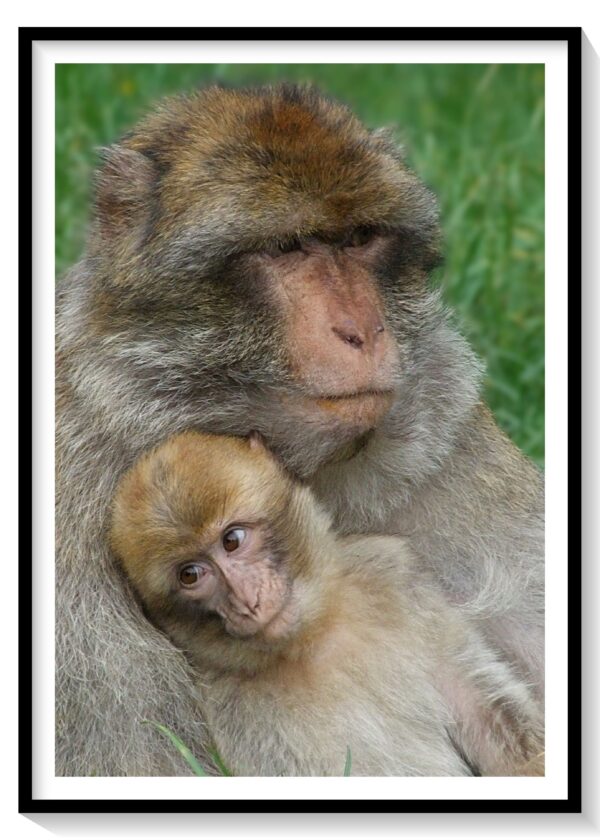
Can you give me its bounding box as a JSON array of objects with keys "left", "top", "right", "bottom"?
[{"left": 19, "top": 27, "right": 582, "bottom": 813}]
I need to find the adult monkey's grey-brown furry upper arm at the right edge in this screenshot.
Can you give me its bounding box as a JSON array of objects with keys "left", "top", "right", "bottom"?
[{"left": 407, "top": 405, "right": 544, "bottom": 700}]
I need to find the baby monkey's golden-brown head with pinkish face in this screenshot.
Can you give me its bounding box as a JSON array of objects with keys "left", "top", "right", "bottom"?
[{"left": 111, "top": 432, "right": 326, "bottom": 644}]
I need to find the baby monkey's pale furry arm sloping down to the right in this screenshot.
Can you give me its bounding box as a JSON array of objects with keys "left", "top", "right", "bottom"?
[{"left": 339, "top": 536, "right": 544, "bottom": 775}]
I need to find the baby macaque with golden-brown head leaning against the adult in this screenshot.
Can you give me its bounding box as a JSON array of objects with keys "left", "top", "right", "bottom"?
[{"left": 111, "top": 432, "right": 544, "bottom": 776}]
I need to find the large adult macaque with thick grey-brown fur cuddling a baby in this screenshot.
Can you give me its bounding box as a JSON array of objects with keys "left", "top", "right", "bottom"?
[{"left": 56, "top": 86, "right": 543, "bottom": 775}]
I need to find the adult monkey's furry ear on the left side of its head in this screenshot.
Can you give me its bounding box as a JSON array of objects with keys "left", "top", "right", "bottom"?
[{"left": 94, "top": 145, "right": 157, "bottom": 246}]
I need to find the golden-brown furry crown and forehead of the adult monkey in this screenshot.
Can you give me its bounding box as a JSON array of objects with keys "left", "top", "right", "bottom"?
[{"left": 116, "top": 85, "right": 436, "bottom": 254}]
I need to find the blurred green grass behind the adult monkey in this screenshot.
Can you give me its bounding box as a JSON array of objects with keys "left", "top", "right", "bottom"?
[{"left": 56, "top": 64, "right": 544, "bottom": 466}]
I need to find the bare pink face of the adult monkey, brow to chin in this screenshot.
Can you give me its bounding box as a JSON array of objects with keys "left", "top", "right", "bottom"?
[{"left": 243, "top": 236, "right": 398, "bottom": 432}]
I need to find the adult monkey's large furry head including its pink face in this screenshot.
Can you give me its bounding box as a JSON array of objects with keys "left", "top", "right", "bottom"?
[{"left": 90, "top": 86, "right": 446, "bottom": 474}]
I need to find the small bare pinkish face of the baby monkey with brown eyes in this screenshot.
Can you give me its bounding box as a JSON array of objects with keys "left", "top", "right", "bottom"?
[{"left": 176, "top": 524, "right": 291, "bottom": 638}]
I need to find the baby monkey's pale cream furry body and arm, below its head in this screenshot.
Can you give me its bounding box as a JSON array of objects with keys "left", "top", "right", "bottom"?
[{"left": 197, "top": 537, "right": 543, "bottom": 776}]
